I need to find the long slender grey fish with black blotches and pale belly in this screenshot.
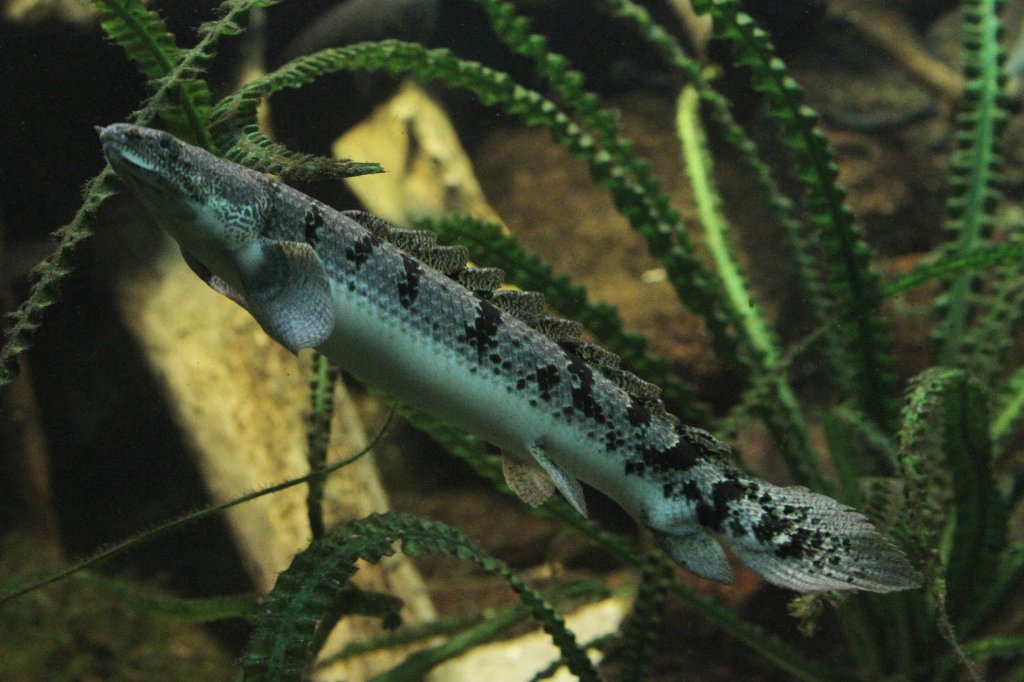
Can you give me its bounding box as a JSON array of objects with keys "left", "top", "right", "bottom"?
[{"left": 100, "top": 124, "right": 918, "bottom": 592}]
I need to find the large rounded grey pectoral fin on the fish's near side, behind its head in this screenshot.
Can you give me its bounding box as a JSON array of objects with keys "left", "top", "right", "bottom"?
[{"left": 239, "top": 240, "right": 334, "bottom": 353}]
